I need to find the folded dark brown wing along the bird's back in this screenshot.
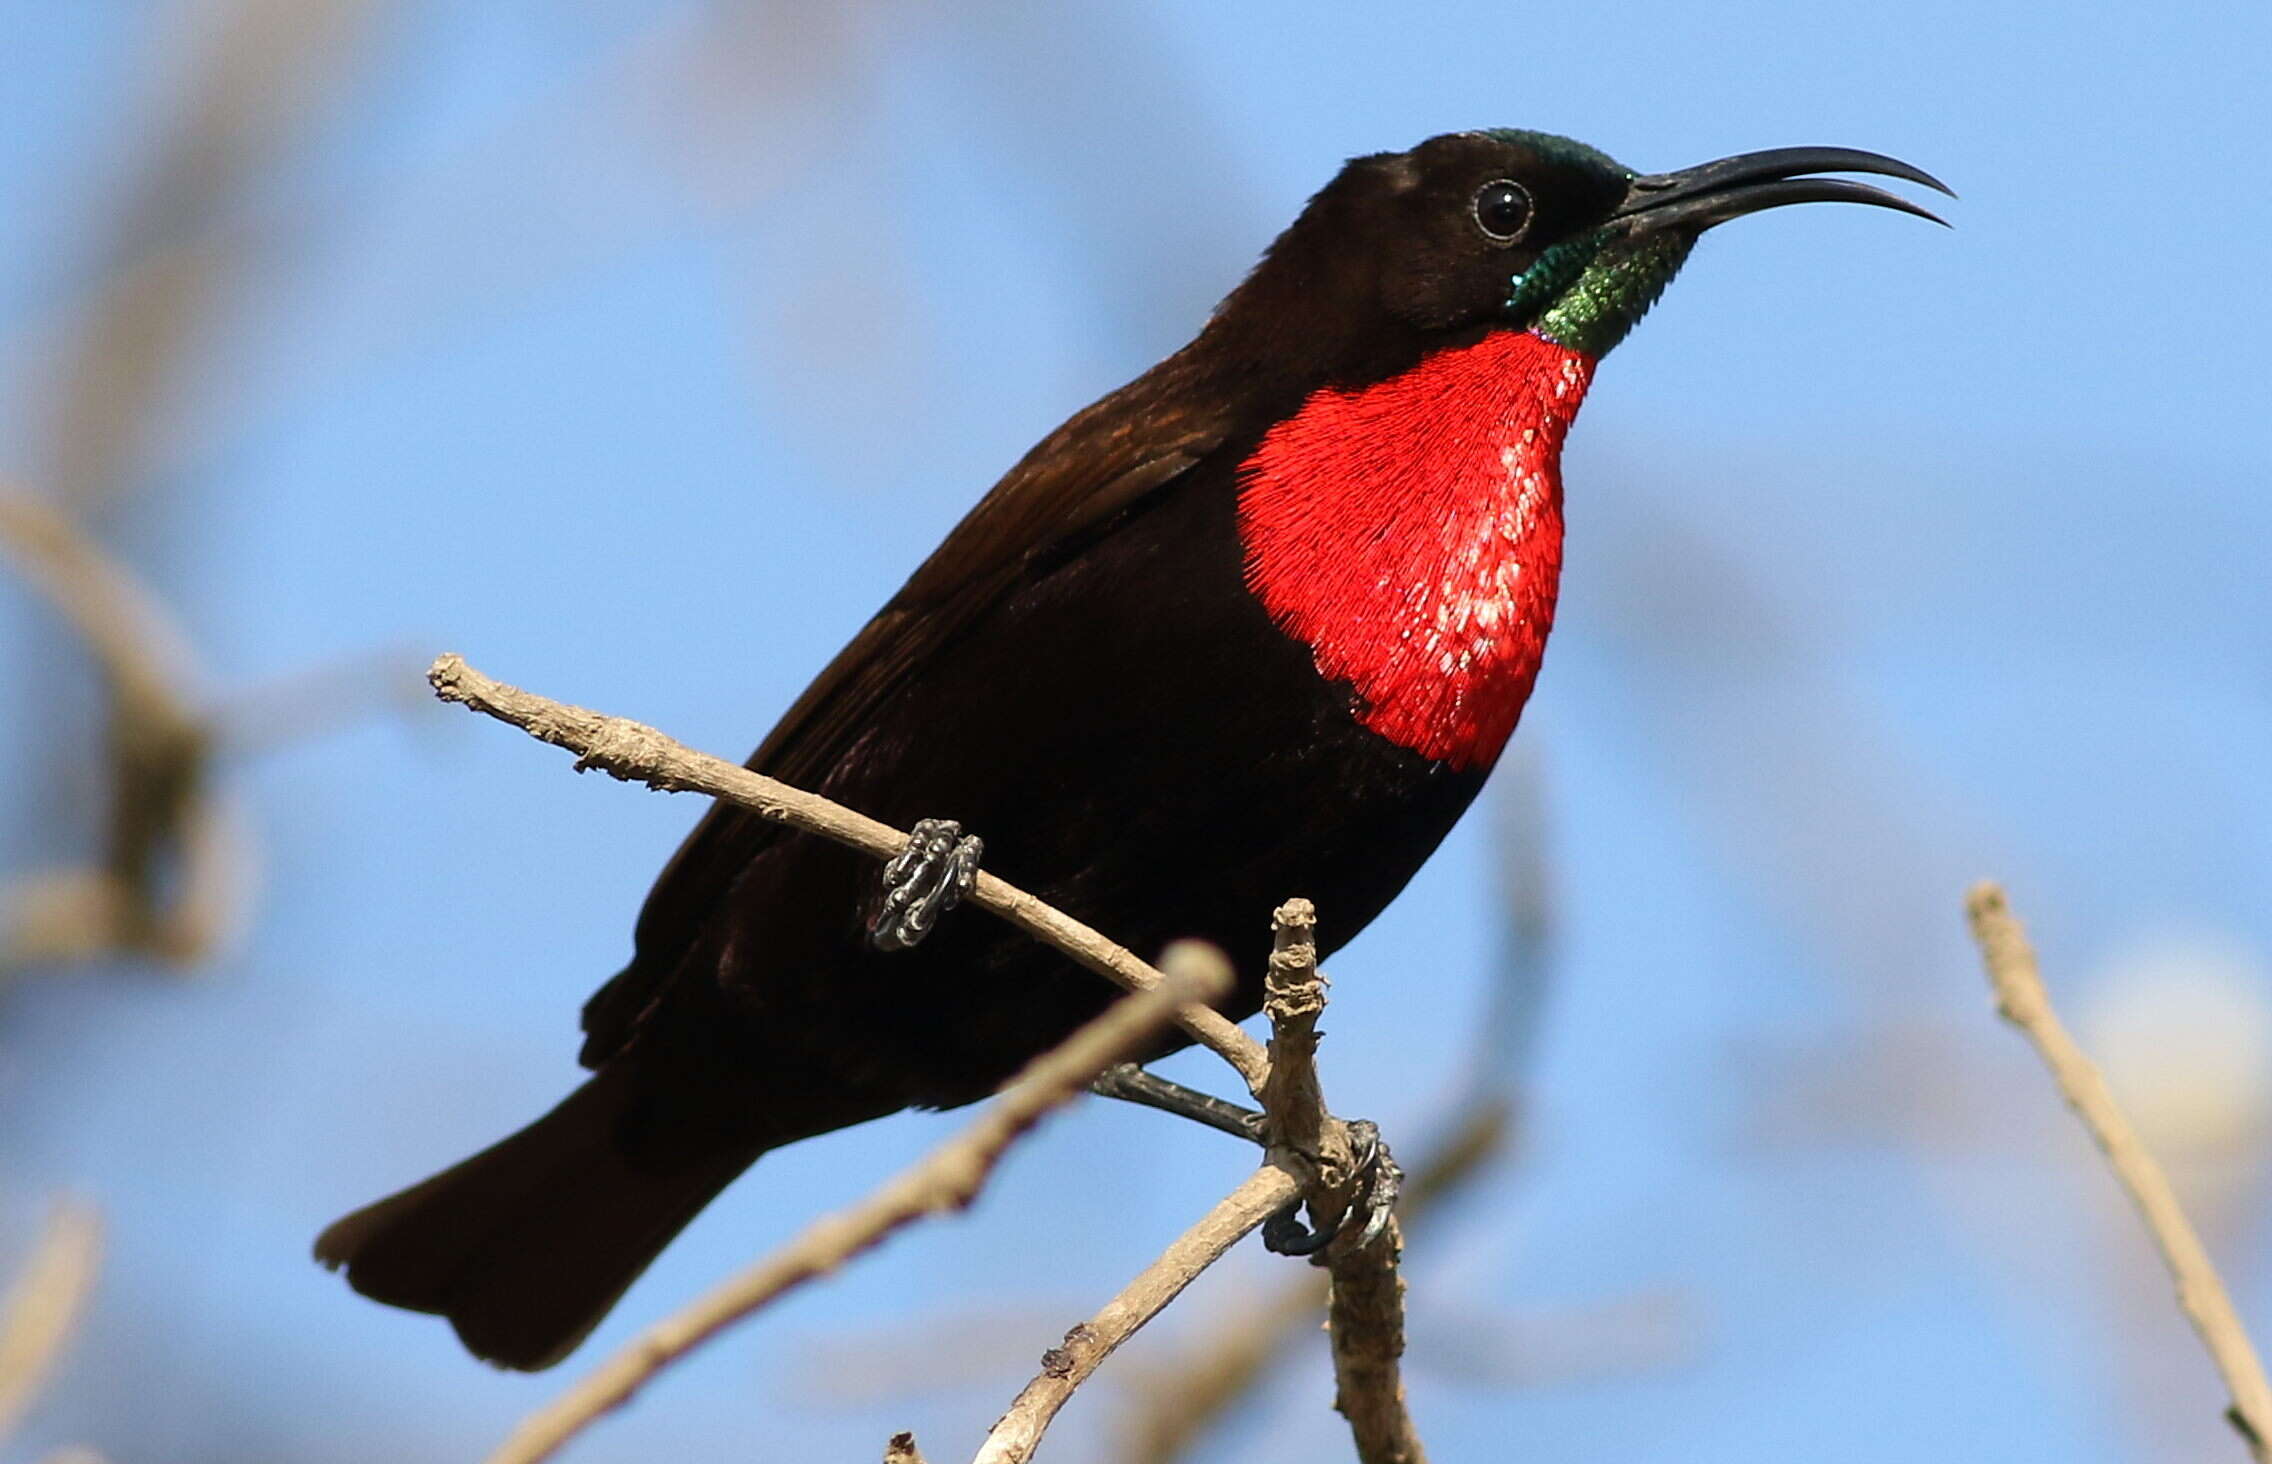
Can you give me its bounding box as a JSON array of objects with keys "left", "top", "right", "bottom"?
[{"left": 584, "top": 357, "right": 1231, "bottom": 1066}]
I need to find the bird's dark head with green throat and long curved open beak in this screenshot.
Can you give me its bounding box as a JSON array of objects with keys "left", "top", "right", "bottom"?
[{"left": 1225, "top": 132, "right": 1949, "bottom": 366}]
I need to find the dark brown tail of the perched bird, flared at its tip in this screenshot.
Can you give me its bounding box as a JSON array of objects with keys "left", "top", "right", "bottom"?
[{"left": 316, "top": 1066, "right": 763, "bottom": 1371}]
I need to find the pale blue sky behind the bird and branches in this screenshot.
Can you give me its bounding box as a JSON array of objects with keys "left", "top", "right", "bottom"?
[{"left": 0, "top": 0, "right": 2272, "bottom": 1464}]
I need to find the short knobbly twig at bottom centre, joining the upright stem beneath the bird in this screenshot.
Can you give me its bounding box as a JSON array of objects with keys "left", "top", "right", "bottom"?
[{"left": 972, "top": 1164, "right": 1304, "bottom": 1464}]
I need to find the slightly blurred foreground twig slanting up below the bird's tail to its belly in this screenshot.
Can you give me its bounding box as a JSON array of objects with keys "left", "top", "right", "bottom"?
[{"left": 491, "top": 941, "right": 1231, "bottom": 1464}]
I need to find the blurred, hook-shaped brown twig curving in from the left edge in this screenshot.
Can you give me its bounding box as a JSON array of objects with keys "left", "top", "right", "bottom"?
[{"left": 0, "top": 489, "right": 241, "bottom": 968}]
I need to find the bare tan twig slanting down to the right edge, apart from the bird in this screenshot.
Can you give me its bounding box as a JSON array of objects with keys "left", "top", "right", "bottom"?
[{"left": 1965, "top": 882, "right": 2272, "bottom": 1464}]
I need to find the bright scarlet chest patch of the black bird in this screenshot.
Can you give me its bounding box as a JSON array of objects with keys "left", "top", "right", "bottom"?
[{"left": 1238, "top": 330, "right": 1593, "bottom": 768}]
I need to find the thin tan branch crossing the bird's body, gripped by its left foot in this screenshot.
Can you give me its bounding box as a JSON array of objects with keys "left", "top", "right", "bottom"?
[{"left": 427, "top": 655, "right": 1270, "bottom": 1093}]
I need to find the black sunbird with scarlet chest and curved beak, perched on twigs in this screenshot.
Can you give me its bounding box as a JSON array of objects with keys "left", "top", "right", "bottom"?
[{"left": 316, "top": 130, "right": 1947, "bottom": 1371}]
